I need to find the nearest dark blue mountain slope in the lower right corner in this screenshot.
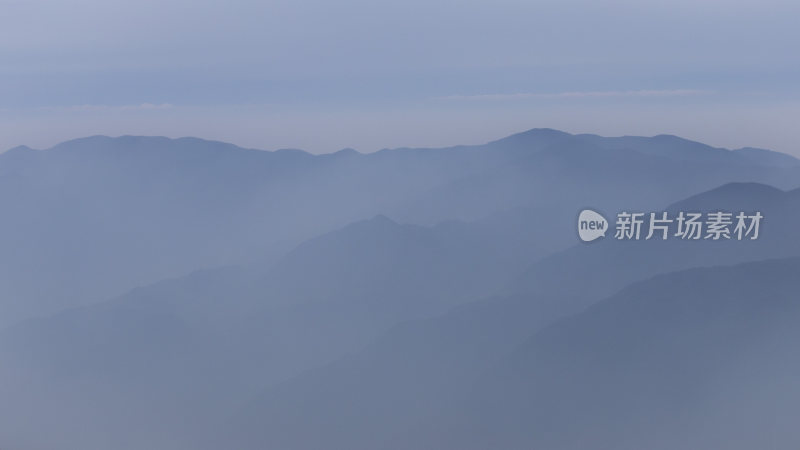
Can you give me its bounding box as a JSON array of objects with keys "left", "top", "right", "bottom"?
[{"left": 444, "top": 258, "right": 800, "bottom": 449}]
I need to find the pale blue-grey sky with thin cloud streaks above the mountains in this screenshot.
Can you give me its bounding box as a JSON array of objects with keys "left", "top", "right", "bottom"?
[{"left": 0, "top": 0, "right": 800, "bottom": 156}]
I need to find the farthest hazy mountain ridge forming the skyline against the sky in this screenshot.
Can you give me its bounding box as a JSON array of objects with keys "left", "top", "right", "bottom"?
[{"left": 0, "top": 130, "right": 800, "bottom": 326}]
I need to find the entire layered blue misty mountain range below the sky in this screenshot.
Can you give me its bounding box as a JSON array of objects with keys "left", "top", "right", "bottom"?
[{"left": 0, "top": 129, "right": 800, "bottom": 450}]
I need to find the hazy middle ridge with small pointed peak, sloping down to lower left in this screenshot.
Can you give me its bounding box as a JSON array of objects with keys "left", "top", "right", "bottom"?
[{"left": 0, "top": 212, "right": 571, "bottom": 448}]
